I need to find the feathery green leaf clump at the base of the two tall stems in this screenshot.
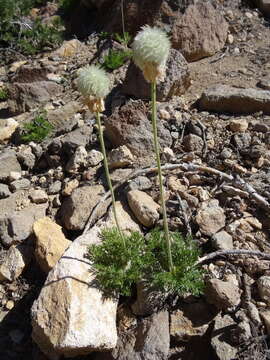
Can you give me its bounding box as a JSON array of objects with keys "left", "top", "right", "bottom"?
[{"left": 88, "top": 228, "right": 204, "bottom": 296}]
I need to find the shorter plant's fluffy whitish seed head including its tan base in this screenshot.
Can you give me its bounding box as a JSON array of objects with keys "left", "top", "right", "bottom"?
[{"left": 77, "top": 65, "right": 110, "bottom": 112}]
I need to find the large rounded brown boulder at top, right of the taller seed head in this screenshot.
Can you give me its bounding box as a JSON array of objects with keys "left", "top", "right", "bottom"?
[{"left": 172, "top": 2, "right": 228, "bottom": 61}]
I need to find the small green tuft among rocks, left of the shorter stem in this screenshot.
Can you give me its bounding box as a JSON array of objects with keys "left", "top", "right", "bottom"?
[{"left": 21, "top": 112, "right": 53, "bottom": 143}]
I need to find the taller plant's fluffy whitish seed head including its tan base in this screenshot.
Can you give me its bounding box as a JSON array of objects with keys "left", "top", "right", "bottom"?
[{"left": 132, "top": 25, "right": 171, "bottom": 82}]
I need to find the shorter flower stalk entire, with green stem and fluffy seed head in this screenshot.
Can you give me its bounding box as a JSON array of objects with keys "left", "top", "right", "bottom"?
[{"left": 77, "top": 65, "right": 125, "bottom": 246}]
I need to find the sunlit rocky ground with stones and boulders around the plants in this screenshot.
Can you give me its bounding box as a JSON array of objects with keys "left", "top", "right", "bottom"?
[{"left": 0, "top": 0, "right": 270, "bottom": 360}]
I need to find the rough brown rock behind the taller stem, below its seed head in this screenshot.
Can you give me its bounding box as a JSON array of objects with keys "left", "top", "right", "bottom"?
[{"left": 105, "top": 101, "right": 172, "bottom": 162}]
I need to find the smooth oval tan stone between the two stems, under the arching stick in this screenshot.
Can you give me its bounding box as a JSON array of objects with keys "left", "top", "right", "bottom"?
[{"left": 127, "top": 190, "right": 160, "bottom": 227}]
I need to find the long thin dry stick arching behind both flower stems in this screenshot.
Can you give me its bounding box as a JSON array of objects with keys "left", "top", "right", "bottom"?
[{"left": 83, "top": 163, "right": 270, "bottom": 234}]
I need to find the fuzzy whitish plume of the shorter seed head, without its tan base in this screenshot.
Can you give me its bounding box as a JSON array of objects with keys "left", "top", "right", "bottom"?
[{"left": 77, "top": 65, "right": 110, "bottom": 99}]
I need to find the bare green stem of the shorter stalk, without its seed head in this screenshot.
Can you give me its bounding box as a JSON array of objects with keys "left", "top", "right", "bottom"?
[{"left": 96, "top": 112, "right": 126, "bottom": 246}]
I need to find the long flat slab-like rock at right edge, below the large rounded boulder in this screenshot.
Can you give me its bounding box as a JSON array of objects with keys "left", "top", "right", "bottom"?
[{"left": 199, "top": 84, "right": 270, "bottom": 114}]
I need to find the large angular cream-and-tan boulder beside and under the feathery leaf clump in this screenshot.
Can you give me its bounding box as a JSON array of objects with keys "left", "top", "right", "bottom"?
[{"left": 32, "top": 226, "right": 117, "bottom": 360}]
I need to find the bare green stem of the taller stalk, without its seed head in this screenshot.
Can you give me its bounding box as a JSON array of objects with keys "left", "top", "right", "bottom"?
[{"left": 151, "top": 82, "right": 173, "bottom": 271}]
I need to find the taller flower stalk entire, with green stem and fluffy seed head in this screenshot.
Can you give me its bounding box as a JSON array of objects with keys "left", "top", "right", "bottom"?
[{"left": 132, "top": 26, "right": 174, "bottom": 272}]
